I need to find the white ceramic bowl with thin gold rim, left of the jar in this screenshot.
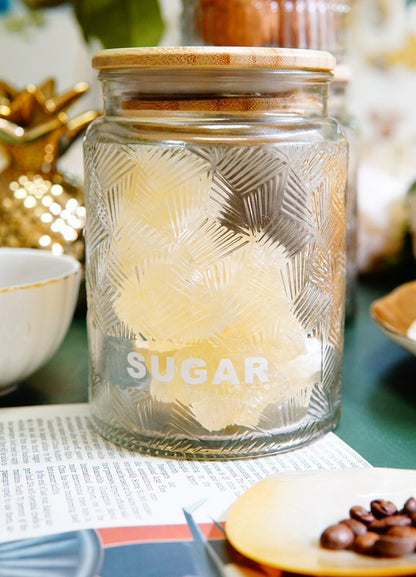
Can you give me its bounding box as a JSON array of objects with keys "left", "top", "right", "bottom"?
[{"left": 0, "top": 248, "right": 81, "bottom": 395}]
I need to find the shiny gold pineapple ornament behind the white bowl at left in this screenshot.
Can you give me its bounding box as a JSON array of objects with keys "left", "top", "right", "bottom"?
[{"left": 0, "top": 78, "right": 98, "bottom": 261}]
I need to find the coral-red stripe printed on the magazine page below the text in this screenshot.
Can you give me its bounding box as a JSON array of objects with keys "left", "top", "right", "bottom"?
[{"left": 97, "top": 523, "right": 224, "bottom": 546}]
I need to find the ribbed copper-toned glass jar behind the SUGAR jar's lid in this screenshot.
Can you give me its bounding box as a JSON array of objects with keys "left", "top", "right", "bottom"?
[{"left": 182, "top": 0, "right": 350, "bottom": 61}]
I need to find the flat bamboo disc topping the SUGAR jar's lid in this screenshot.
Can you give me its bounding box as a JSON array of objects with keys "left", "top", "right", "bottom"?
[{"left": 92, "top": 46, "right": 335, "bottom": 72}]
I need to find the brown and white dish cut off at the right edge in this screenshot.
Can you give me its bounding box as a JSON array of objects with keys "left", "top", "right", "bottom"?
[{"left": 370, "top": 281, "right": 416, "bottom": 355}]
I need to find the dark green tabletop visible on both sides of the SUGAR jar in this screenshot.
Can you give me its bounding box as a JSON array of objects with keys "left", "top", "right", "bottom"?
[{"left": 0, "top": 267, "right": 416, "bottom": 469}]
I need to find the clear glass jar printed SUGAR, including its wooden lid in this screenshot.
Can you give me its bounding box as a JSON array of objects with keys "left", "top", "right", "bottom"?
[{"left": 84, "top": 47, "right": 347, "bottom": 458}]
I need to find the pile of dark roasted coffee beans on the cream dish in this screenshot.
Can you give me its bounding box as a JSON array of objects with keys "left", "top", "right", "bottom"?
[{"left": 321, "top": 497, "right": 416, "bottom": 557}]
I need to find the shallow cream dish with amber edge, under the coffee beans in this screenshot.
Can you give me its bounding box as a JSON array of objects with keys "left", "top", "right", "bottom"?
[{"left": 226, "top": 468, "right": 416, "bottom": 577}]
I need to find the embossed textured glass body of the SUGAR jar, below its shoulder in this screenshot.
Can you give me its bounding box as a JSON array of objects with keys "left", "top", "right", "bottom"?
[{"left": 85, "top": 143, "right": 346, "bottom": 458}]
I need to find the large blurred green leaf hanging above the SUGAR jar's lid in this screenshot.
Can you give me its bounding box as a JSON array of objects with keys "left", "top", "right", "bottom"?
[{"left": 72, "top": 0, "right": 164, "bottom": 48}]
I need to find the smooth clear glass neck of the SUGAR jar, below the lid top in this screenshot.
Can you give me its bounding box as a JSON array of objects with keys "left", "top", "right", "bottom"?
[{"left": 99, "top": 69, "right": 332, "bottom": 117}]
